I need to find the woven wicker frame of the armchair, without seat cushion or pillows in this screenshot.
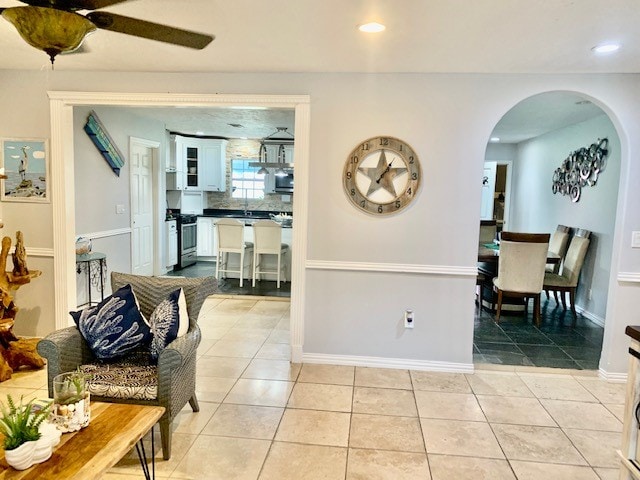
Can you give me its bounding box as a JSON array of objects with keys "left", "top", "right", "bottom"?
[{"left": 38, "top": 272, "right": 217, "bottom": 460}]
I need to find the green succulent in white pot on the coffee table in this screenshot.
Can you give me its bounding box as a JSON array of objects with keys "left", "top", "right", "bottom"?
[{"left": 0, "top": 395, "right": 53, "bottom": 470}]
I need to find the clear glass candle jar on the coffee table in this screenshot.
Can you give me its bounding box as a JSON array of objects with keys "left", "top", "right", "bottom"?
[{"left": 49, "top": 372, "right": 91, "bottom": 432}]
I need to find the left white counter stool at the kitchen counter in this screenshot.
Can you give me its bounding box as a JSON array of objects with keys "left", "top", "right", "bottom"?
[{"left": 216, "top": 218, "right": 253, "bottom": 287}]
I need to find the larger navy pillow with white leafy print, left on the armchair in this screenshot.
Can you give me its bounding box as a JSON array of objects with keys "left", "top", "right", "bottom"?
[{"left": 69, "top": 285, "right": 151, "bottom": 360}]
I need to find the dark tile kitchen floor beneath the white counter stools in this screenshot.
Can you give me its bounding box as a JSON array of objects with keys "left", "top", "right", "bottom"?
[{"left": 167, "top": 262, "right": 291, "bottom": 297}]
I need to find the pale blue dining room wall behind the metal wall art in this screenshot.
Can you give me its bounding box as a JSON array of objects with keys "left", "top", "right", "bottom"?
[{"left": 504, "top": 114, "right": 621, "bottom": 323}]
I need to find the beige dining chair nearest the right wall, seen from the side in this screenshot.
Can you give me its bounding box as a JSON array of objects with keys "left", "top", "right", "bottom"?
[{"left": 543, "top": 230, "right": 591, "bottom": 318}]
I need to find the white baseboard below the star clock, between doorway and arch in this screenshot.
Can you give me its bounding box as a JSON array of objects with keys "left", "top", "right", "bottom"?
[{"left": 302, "top": 348, "right": 474, "bottom": 373}]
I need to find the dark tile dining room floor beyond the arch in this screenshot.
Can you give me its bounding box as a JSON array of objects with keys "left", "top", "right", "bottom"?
[{"left": 473, "top": 294, "right": 604, "bottom": 370}]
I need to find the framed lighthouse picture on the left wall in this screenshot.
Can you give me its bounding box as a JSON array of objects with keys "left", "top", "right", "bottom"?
[{"left": 0, "top": 138, "right": 49, "bottom": 203}]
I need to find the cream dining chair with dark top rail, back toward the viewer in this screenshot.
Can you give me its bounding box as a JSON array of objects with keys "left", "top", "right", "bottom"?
[{"left": 493, "top": 232, "right": 551, "bottom": 325}]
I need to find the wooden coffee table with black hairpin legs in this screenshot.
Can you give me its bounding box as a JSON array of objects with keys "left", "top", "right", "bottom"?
[{"left": 0, "top": 402, "right": 164, "bottom": 480}]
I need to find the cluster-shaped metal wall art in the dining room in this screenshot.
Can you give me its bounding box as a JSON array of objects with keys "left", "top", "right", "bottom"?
[{"left": 551, "top": 138, "right": 609, "bottom": 202}]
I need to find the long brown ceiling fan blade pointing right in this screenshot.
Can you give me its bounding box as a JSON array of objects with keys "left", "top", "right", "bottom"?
[{"left": 86, "top": 12, "right": 215, "bottom": 50}]
